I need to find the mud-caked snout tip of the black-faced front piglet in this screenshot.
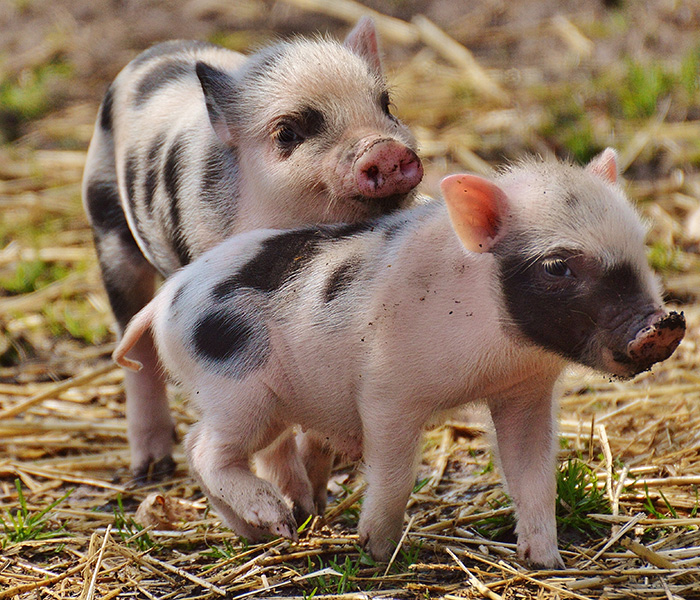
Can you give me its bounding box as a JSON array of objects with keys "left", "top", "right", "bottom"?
[{"left": 627, "top": 311, "right": 685, "bottom": 373}]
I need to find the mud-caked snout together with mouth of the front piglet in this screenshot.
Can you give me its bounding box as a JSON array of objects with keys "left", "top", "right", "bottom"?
[{"left": 606, "top": 312, "right": 685, "bottom": 377}]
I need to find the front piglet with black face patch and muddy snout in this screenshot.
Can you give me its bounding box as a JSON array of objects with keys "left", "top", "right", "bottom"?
[{"left": 115, "top": 150, "right": 685, "bottom": 567}]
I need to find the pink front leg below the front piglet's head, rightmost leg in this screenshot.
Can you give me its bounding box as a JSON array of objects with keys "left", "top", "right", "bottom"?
[{"left": 489, "top": 382, "right": 564, "bottom": 569}]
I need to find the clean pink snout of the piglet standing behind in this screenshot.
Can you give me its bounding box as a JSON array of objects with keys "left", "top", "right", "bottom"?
[{"left": 353, "top": 139, "right": 423, "bottom": 198}]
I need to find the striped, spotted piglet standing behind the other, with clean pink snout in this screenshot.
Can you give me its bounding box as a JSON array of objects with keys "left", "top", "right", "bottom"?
[{"left": 83, "top": 19, "right": 423, "bottom": 478}]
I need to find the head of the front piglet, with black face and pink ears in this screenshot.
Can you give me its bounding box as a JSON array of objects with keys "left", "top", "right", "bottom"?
[{"left": 441, "top": 149, "right": 685, "bottom": 377}]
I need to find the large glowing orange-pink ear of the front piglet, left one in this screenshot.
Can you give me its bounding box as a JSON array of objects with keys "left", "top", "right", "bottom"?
[{"left": 440, "top": 175, "right": 508, "bottom": 252}]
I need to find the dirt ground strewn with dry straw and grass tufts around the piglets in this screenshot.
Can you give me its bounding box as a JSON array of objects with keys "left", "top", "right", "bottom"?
[{"left": 0, "top": 0, "right": 700, "bottom": 600}]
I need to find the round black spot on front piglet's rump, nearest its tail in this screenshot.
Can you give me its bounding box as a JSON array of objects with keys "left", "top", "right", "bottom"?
[{"left": 192, "top": 310, "right": 267, "bottom": 377}]
